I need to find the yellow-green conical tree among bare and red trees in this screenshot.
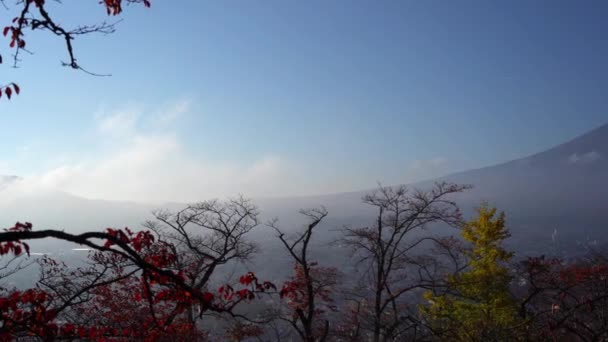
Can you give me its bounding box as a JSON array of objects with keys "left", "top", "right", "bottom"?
[{"left": 421, "top": 205, "right": 518, "bottom": 341}]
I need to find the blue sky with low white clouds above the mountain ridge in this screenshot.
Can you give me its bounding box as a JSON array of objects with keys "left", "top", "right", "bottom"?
[{"left": 0, "top": 0, "right": 608, "bottom": 200}]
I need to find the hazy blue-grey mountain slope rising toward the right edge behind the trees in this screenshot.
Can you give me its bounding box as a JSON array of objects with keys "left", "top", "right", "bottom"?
[{"left": 260, "top": 124, "right": 608, "bottom": 254}]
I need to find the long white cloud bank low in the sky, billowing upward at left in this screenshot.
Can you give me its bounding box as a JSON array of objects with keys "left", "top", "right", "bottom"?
[{"left": 1, "top": 101, "right": 460, "bottom": 202}]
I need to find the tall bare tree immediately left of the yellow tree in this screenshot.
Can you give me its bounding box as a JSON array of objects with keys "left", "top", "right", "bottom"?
[{"left": 339, "top": 183, "right": 469, "bottom": 342}]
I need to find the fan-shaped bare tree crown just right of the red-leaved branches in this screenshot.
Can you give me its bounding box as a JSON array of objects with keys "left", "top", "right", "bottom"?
[{"left": 144, "top": 197, "right": 259, "bottom": 322}]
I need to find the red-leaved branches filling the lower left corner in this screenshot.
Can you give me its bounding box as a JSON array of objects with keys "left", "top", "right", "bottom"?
[{"left": 0, "top": 219, "right": 276, "bottom": 341}]
